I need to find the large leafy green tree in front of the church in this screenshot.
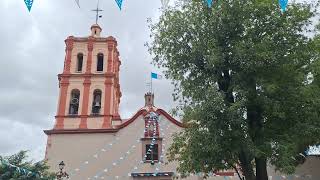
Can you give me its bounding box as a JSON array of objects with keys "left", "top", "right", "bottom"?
[{"left": 149, "top": 0, "right": 320, "bottom": 180}]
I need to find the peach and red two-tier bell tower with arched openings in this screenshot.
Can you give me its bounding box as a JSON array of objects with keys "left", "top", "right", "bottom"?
[{"left": 54, "top": 24, "right": 121, "bottom": 130}]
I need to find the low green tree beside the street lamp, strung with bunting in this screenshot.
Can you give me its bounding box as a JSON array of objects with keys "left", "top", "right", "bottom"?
[{"left": 0, "top": 151, "right": 55, "bottom": 180}]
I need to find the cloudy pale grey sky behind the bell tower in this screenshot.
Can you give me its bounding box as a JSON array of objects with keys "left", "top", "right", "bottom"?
[{"left": 0, "top": 0, "right": 174, "bottom": 160}]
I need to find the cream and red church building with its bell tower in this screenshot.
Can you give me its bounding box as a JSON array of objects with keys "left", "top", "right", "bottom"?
[{"left": 44, "top": 24, "right": 320, "bottom": 180}]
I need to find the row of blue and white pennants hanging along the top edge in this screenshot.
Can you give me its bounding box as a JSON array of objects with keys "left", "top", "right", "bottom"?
[{"left": 24, "top": 0, "right": 288, "bottom": 12}]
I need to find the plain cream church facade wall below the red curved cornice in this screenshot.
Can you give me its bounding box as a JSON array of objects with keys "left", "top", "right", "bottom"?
[{"left": 47, "top": 112, "right": 238, "bottom": 180}]
